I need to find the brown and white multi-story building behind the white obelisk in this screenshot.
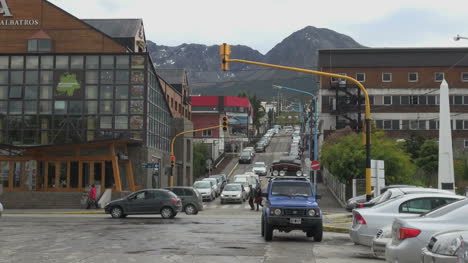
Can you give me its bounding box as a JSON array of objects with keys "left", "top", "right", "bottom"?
[{"left": 318, "top": 48, "right": 468, "bottom": 156}]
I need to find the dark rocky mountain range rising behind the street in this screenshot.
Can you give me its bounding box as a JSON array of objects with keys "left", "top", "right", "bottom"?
[{"left": 148, "top": 26, "right": 364, "bottom": 98}]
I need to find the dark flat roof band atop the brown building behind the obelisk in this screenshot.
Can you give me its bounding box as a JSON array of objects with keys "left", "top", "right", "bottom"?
[{"left": 318, "top": 48, "right": 468, "bottom": 68}]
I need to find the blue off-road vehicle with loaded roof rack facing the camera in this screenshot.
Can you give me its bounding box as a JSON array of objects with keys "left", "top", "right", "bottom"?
[{"left": 261, "top": 176, "right": 323, "bottom": 242}]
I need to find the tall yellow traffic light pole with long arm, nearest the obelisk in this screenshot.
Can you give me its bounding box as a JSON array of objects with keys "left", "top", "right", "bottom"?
[{"left": 219, "top": 44, "right": 371, "bottom": 201}]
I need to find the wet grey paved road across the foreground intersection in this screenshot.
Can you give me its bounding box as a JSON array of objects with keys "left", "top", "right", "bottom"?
[{"left": 0, "top": 214, "right": 381, "bottom": 263}]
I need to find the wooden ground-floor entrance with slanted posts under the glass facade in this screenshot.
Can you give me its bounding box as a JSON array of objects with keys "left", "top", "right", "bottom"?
[{"left": 0, "top": 141, "right": 142, "bottom": 192}]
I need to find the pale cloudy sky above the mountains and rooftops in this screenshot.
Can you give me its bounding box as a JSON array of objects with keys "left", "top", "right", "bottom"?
[{"left": 49, "top": 0, "right": 468, "bottom": 54}]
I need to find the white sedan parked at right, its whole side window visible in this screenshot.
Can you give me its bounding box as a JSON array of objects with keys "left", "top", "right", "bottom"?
[{"left": 349, "top": 193, "right": 465, "bottom": 246}]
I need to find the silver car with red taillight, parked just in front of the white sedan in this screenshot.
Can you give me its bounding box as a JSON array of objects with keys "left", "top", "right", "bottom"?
[{"left": 385, "top": 199, "right": 468, "bottom": 263}]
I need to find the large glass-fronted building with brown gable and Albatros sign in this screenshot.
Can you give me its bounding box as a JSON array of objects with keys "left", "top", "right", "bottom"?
[{"left": 0, "top": 0, "right": 188, "bottom": 207}]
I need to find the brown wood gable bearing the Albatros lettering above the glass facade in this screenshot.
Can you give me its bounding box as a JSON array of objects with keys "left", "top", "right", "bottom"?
[{"left": 0, "top": 0, "right": 126, "bottom": 53}]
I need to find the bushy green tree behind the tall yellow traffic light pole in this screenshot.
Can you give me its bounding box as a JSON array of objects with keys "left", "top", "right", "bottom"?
[{"left": 320, "top": 131, "right": 416, "bottom": 184}]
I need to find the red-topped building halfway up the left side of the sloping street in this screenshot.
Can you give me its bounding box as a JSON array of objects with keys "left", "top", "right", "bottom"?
[{"left": 191, "top": 96, "right": 252, "bottom": 160}]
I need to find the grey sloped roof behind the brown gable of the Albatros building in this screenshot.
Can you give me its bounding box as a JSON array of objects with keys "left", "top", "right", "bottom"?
[{"left": 82, "top": 18, "right": 142, "bottom": 38}]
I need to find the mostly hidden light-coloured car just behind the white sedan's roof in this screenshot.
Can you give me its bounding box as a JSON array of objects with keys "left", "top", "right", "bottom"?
[{"left": 352, "top": 187, "right": 455, "bottom": 211}]
